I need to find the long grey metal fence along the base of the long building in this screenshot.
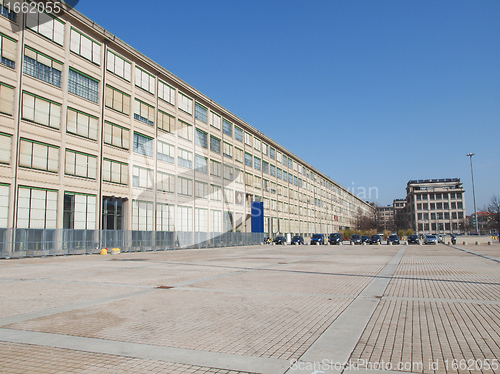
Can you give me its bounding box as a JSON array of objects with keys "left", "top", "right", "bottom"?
[{"left": 0, "top": 229, "right": 264, "bottom": 258}]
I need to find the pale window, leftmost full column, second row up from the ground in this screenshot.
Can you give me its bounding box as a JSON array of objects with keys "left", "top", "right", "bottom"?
[{"left": 19, "top": 138, "right": 59, "bottom": 173}]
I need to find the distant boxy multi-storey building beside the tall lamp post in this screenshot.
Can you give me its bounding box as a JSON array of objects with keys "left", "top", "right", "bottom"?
[{"left": 406, "top": 178, "right": 465, "bottom": 234}]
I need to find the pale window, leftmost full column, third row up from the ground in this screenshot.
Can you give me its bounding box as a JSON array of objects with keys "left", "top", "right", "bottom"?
[{"left": 21, "top": 91, "right": 61, "bottom": 129}]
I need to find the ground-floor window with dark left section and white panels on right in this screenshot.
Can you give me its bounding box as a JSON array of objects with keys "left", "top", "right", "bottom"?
[{"left": 63, "top": 192, "right": 97, "bottom": 230}]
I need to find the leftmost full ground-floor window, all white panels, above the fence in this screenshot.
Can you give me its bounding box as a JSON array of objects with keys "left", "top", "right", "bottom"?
[{"left": 17, "top": 186, "right": 57, "bottom": 229}]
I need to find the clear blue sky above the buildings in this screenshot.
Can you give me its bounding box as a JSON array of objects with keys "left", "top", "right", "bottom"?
[{"left": 76, "top": 0, "right": 500, "bottom": 214}]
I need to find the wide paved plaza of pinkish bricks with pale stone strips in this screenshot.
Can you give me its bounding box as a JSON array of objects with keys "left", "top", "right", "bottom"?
[{"left": 0, "top": 243, "right": 500, "bottom": 374}]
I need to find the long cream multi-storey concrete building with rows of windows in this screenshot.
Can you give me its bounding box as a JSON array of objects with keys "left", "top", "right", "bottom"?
[{"left": 0, "top": 0, "right": 372, "bottom": 243}]
